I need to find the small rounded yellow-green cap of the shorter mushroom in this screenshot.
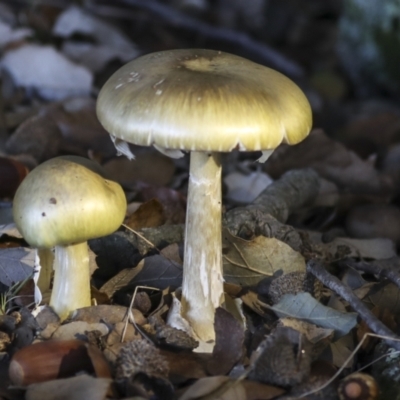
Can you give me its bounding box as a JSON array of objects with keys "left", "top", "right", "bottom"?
[{"left": 13, "top": 157, "right": 126, "bottom": 248}]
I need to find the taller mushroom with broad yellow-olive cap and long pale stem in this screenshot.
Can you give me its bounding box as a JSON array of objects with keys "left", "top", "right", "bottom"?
[{"left": 97, "top": 49, "right": 312, "bottom": 341}]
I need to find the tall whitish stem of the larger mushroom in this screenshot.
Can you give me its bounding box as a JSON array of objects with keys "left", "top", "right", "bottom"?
[{"left": 182, "top": 151, "right": 223, "bottom": 341}]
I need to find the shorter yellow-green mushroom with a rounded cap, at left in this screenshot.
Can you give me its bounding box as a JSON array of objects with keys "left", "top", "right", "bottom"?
[{"left": 13, "top": 157, "right": 126, "bottom": 320}]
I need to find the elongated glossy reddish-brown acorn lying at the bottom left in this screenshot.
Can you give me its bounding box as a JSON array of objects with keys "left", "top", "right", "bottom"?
[{"left": 9, "top": 340, "right": 111, "bottom": 386}]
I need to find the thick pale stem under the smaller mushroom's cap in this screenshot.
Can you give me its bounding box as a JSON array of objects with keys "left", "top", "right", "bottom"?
[{"left": 50, "top": 242, "right": 91, "bottom": 321}]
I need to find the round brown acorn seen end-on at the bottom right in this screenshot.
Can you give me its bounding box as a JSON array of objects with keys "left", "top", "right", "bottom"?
[{"left": 338, "top": 372, "right": 379, "bottom": 400}]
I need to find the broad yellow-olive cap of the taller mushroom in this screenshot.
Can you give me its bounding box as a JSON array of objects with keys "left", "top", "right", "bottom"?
[{"left": 97, "top": 49, "right": 312, "bottom": 152}]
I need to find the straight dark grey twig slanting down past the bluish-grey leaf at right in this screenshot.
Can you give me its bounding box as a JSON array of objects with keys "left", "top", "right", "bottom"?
[{"left": 307, "top": 259, "right": 400, "bottom": 350}]
